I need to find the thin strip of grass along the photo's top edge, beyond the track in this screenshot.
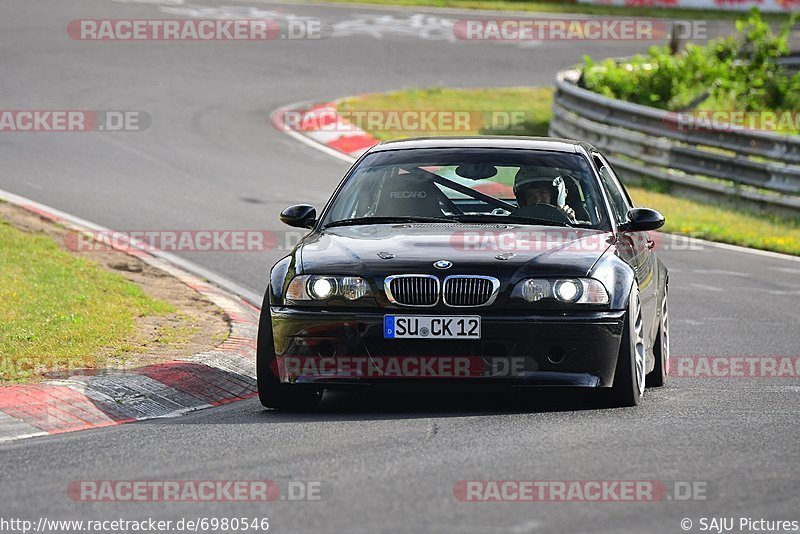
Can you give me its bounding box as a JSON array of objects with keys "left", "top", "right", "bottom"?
[{"left": 316, "top": 0, "right": 787, "bottom": 22}]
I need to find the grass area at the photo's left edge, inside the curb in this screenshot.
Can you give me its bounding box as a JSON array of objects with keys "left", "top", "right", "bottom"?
[{"left": 0, "top": 220, "right": 174, "bottom": 382}]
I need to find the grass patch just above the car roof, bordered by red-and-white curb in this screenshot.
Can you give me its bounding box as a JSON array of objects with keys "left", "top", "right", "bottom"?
[{"left": 337, "top": 87, "right": 553, "bottom": 141}]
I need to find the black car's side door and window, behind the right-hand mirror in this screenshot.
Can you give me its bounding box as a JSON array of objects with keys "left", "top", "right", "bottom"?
[{"left": 593, "top": 153, "right": 659, "bottom": 346}]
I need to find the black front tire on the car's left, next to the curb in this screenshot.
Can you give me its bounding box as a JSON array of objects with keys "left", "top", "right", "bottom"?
[{"left": 256, "top": 296, "right": 322, "bottom": 411}]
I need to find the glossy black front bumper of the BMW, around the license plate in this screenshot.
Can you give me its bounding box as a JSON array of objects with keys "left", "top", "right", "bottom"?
[{"left": 270, "top": 306, "right": 625, "bottom": 388}]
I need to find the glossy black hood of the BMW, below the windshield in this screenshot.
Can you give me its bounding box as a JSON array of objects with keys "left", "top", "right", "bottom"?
[{"left": 297, "top": 224, "right": 611, "bottom": 280}]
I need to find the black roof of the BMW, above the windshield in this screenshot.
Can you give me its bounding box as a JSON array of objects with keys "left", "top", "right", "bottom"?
[{"left": 368, "top": 135, "right": 595, "bottom": 154}]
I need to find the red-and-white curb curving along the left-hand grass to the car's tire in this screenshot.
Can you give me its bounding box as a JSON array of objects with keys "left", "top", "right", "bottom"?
[{"left": 0, "top": 192, "right": 260, "bottom": 443}]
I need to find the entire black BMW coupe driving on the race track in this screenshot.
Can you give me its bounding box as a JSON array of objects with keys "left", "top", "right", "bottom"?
[{"left": 257, "top": 137, "right": 669, "bottom": 409}]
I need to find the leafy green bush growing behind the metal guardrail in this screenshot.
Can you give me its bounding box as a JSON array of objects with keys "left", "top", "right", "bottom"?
[{"left": 581, "top": 9, "right": 800, "bottom": 111}]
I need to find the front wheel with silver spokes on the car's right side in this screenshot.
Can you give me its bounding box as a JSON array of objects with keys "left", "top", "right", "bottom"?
[{"left": 611, "top": 283, "right": 646, "bottom": 407}]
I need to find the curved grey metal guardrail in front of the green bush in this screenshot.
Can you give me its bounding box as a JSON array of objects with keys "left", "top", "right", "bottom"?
[{"left": 550, "top": 69, "right": 800, "bottom": 218}]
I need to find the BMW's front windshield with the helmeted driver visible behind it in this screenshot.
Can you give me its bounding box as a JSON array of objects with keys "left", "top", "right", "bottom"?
[{"left": 323, "top": 148, "right": 608, "bottom": 229}]
